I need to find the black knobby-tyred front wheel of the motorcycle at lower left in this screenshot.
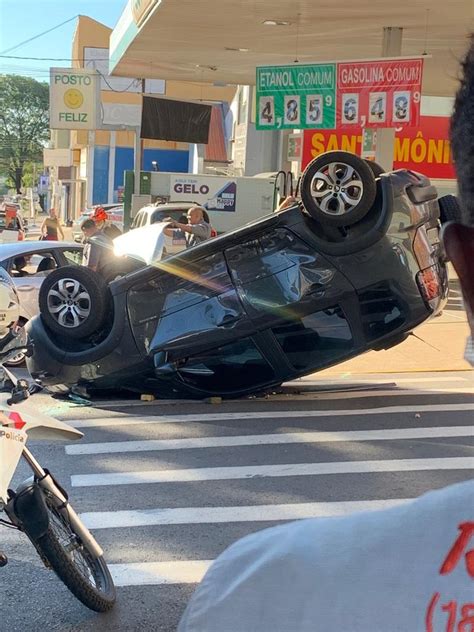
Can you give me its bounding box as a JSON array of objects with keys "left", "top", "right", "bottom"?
[{"left": 35, "top": 495, "right": 116, "bottom": 612}]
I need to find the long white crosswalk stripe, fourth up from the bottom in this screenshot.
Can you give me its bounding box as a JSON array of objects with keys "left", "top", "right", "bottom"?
[{"left": 66, "top": 426, "right": 474, "bottom": 455}]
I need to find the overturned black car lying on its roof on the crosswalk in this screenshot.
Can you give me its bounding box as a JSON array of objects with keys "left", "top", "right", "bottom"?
[{"left": 28, "top": 152, "right": 448, "bottom": 398}]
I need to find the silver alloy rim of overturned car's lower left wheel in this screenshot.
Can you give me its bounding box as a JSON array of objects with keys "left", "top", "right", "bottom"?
[{"left": 47, "top": 278, "right": 91, "bottom": 329}]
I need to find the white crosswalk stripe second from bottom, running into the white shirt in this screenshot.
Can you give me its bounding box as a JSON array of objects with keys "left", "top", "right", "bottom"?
[{"left": 81, "top": 498, "right": 409, "bottom": 529}]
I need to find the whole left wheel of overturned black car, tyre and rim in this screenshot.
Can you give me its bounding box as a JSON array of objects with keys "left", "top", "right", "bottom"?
[{"left": 39, "top": 266, "right": 109, "bottom": 339}]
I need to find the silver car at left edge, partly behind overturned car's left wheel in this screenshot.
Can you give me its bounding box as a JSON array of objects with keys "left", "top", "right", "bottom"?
[{"left": 0, "top": 241, "right": 82, "bottom": 365}]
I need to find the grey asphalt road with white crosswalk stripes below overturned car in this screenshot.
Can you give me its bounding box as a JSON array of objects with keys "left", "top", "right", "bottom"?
[{"left": 0, "top": 371, "right": 474, "bottom": 632}]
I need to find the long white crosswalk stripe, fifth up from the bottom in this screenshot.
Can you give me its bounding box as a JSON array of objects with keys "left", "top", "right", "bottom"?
[{"left": 68, "top": 404, "right": 474, "bottom": 428}]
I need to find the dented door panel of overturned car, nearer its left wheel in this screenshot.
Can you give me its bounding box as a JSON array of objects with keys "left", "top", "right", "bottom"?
[{"left": 128, "top": 252, "right": 253, "bottom": 358}]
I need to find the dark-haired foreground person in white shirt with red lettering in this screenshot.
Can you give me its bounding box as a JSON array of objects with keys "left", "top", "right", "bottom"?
[{"left": 178, "top": 39, "right": 474, "bottom": 632}]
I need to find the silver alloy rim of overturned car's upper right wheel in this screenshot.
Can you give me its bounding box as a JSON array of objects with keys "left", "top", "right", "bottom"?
[{"left": 311, "top": 162, "right": 364, "bottom": 216}]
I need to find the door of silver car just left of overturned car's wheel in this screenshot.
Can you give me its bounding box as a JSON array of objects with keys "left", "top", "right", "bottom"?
[{"left": 8, "top": 248, "right": 61, "bottom": 320}]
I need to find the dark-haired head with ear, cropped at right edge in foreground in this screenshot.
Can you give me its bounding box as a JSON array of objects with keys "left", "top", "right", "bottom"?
[{"left": 443, "top": 36, "right": 474, "bottom": 362}]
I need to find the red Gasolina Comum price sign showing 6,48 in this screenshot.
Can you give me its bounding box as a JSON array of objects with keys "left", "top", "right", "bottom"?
[{"left": 337, "top": 59, "right": 423, "bottom": 128}]
